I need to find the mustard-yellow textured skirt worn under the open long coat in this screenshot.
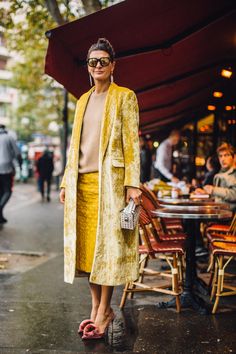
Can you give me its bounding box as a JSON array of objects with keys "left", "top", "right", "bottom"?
[{"left": 76, "top": 172, "right": 98, "bottom": 273}]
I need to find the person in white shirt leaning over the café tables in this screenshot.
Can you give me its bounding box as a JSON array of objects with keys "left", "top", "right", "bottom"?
[{"left": 154, "top": 130, "right": 180, "bottom": 183}]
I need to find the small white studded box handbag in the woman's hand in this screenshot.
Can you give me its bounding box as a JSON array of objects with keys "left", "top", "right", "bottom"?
[{"left": 120, "top": 199, "right": 139, "bottom": 230}]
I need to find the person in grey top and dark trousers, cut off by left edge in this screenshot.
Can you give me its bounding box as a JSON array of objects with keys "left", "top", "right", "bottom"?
[{"left": 0, "top": 124, "right": 21, "bottom": 224}]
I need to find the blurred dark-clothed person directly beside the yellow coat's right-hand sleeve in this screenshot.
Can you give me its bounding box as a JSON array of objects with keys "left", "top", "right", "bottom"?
[{"left": 139, "top": 136, "right": 152, "bottom": 183}]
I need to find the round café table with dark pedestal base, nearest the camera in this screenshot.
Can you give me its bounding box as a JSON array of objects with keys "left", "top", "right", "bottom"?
[{"left": 152, "top": 203, "right": 232, "bottom": 314}]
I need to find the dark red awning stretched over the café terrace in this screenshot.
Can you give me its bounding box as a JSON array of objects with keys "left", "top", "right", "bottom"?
[{"left": 45, "top": 0, "right": 236, "bottom": 133}]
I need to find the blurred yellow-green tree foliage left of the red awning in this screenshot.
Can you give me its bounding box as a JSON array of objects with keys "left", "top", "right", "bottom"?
[{"left": 0, "top": 0, "right": 76, "bottom": 140}]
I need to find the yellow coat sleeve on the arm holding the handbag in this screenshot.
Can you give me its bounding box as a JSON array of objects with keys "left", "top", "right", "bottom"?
[{"left": 122, "top": 91, "right": 140, "bottom": 188}]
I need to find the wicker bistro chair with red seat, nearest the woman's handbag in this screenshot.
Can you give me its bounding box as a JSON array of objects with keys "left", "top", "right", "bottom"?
[{"left": 120, "top": 206, "right": 184, "bottom": 312}]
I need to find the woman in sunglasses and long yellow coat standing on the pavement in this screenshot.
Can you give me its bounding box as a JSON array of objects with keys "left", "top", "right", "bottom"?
[{"left": 60, "top": 38, "right": 141, "bottom": 339}]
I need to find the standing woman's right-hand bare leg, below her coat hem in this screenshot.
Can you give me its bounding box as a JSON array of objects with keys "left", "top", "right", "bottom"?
[{"left": 95, "top": 285, "right": 114, "bottom": 333}]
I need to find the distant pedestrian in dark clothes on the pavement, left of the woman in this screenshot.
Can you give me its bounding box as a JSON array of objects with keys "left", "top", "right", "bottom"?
[{"left": 37, "top": 149, "right": 54, "bottom": 202}]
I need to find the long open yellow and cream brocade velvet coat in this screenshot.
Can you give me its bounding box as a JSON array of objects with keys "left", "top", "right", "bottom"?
[{"left": 61, "top": 83, "right": 140, "bottom": 286}]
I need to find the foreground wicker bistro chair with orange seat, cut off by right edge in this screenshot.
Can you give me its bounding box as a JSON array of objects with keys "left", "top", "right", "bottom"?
[{"left": 210, "top": 241, "right": 236, "bottom": 314}]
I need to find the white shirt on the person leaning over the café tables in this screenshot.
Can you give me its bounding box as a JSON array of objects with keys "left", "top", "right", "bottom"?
[{"left": 154, "top": 139, "right": 173, "bottom": 180}]
